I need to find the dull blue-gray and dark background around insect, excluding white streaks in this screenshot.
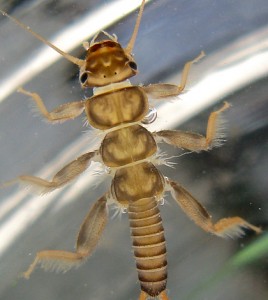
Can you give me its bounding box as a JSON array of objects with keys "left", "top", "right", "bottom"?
[{"left": 0, "top": 0, "right": 268, "bottom": 300}]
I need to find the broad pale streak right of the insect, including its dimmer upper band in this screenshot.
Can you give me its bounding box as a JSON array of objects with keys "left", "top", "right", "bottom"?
[{"left": 149, "top": 27, "right": 268, "bottom": 131}]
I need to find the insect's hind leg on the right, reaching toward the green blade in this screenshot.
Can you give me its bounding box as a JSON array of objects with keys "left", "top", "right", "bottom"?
[{"left": 168, "top": 181, "right": 261, "bottom": 237}]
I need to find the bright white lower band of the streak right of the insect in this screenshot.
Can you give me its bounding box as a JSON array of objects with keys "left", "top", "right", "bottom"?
[{"left": 149, "top": 51, "right": 268, "bottom": 131}]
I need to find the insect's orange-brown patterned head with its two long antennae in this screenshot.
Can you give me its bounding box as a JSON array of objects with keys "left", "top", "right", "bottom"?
[{"left": 0, "top": 0, "right": 145, "bottom": 87}]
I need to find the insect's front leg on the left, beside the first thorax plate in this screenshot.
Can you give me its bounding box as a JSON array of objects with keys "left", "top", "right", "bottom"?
[{"left": 18, "top": 88, "right": 85, "bottom": 123}]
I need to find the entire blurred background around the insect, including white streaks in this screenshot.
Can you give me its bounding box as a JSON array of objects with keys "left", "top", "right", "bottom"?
[{"left": 0, "top": 0, "right": 268, "bottom": 300}]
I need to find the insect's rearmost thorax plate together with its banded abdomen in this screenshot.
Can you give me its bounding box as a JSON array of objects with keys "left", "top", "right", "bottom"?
[{"left": 112, "top": 162, "right": 167, "bottom": 297}]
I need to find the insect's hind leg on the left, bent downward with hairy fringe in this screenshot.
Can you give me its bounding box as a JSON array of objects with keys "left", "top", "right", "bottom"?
[{"left": 23, "top": 196, "right": 107, "bottom": 279}]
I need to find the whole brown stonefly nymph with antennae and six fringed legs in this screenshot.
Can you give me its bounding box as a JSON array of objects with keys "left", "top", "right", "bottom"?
[{"left": 1, "top": 0, "right": 261, "bottom": 300}]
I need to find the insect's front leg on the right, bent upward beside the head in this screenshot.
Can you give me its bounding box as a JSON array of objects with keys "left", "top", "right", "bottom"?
[{"left": 143, "top": 51, "right": 205, "bottom": 98}]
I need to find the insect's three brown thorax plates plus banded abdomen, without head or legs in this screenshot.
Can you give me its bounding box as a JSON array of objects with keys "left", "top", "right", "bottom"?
[{"left": 92, "top": 87, "right": 167, "bottom": 297}]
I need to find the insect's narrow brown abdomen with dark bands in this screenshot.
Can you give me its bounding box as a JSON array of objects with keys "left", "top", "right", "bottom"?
[{"left": 128, "top": 197, "right": 167, "bottom": 297}]
